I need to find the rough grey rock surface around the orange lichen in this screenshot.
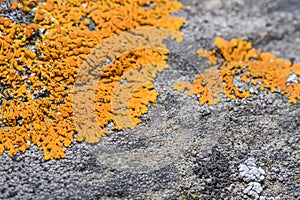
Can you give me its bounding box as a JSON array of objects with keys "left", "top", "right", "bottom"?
[{"left": 0, "top": 0, "right": 300, "bottom": 200}]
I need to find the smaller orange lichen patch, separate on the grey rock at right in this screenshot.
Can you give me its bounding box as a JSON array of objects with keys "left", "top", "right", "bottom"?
[{"left": 174, "top": 37, "right": 300, "bottom": 105}]
